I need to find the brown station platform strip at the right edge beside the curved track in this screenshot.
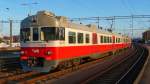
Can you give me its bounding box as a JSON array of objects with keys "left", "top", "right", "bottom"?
[{"left": 134, "top": 45, "right": 150, "bottom": 84}]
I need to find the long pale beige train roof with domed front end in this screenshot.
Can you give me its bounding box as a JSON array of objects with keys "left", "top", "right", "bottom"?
[{"left": 21, "top": 11, "right": 129, "bottom": 37}]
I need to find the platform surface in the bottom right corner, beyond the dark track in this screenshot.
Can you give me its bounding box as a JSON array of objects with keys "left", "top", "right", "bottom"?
[{"left": 139, "top": 46, "right": 150, "bottom": 84}]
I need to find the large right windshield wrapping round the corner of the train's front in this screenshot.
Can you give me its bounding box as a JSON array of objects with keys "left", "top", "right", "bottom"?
[{"left": 40, "top": 27, "right": 65, "bottom": 41}]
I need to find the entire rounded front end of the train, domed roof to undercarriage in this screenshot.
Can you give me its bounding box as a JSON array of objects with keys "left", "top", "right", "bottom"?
[{"left": 20, "top": 11, "right": 64, "bottom": 72}]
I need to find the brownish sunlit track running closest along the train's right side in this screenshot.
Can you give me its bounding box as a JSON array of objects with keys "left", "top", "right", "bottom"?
[{"left": 0, "top": 47, "right": 132, "bottom": 84}]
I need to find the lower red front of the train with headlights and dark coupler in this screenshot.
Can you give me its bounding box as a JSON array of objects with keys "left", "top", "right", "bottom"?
[{"left": 20, "top": 47, "right": 56, "bottom": 72}]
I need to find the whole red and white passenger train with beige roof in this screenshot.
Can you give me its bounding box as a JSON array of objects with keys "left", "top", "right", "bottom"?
[{"left": 20, "top": 11, "right": 131, "bottom": 72}]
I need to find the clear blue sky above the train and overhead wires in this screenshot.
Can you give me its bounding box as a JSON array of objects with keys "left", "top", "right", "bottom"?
[{"left": 0, "top": 0, "right": 150, "bottom": 37}]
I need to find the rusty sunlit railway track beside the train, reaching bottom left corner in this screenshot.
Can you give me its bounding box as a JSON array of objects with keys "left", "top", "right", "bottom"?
[{"left": 0, "top": 47, "right": 131, "bottom": 84}]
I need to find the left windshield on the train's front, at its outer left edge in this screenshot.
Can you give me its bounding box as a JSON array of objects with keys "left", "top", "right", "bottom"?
[{"left": 20, "top": 28, "right": 31, "bottom": 42}]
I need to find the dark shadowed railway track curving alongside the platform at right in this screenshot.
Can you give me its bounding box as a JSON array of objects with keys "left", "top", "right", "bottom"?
[{"left": 83, "top": 46, "right": 148, "bottom": 84}]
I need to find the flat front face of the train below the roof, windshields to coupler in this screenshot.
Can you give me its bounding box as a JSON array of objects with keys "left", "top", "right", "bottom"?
[{"left": 20, "top": 27, "right": 61, "bottom": 72}]
